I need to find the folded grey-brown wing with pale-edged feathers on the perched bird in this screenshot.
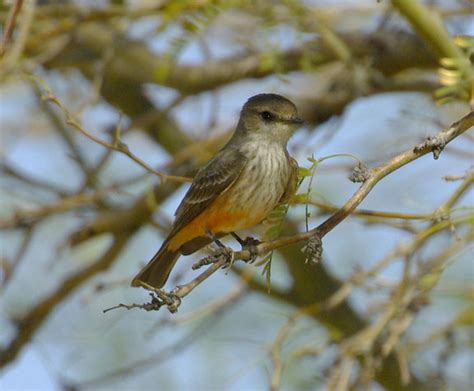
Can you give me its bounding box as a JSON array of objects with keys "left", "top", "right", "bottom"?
[{"left": 170, "top": 150, "right": 247, "bottom": 237}]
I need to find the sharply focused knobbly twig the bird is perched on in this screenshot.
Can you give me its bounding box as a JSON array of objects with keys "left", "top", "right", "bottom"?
[{"left": 108, "top": 111, "right": 474, "bottom": 313}]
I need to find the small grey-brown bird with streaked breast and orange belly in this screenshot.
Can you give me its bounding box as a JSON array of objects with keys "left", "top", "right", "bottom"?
[{"left": 132, "top": 94, "right": 303, "bottom": 289}]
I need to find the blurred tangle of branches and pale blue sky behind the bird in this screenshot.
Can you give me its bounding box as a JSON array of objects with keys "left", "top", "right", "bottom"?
[{"left": 0, "top": 0, "right": 474, "bottom": 390}]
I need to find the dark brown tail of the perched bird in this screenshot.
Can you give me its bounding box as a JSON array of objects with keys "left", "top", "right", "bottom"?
[{"left": 132, "top": 243, "right": 181, "bottom": 289}]
